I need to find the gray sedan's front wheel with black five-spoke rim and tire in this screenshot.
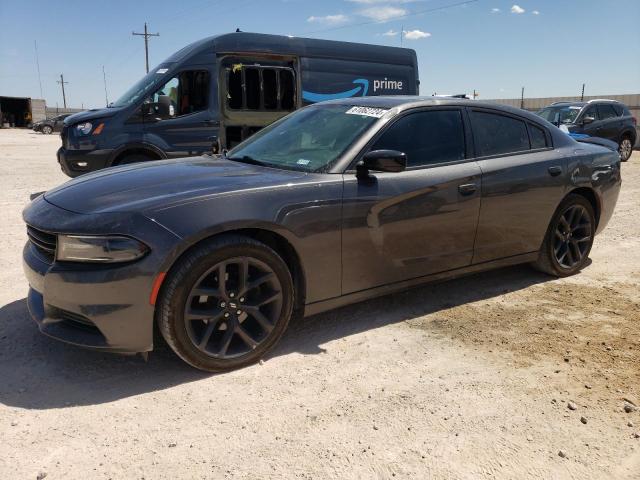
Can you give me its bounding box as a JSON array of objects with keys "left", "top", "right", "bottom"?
[{"left": 156, "top": 235, "right": 295, "bottom": 372}]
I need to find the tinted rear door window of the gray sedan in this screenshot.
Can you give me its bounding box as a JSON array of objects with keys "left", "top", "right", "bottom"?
[{"left": 471, "top": 111, "right": 530, "bottom": 157}]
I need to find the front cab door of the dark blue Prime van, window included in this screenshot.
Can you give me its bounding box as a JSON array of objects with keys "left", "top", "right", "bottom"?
[{"left": 143, "top": 67, "right": 218, "bottom": 158}]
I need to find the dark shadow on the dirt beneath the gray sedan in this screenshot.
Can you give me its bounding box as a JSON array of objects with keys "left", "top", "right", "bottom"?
[{"left": 0, "top": 266, "right": 552, "bottom": 409}]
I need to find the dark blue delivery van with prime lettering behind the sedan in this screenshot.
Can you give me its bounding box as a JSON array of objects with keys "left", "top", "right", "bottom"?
[{"left": 58, "top": 32, "right": 419, "bottom": 177}]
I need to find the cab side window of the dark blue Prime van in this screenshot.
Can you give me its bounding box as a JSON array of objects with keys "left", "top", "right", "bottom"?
[{"left": 145, "top": 70, "right": 209, "bottom": 120}]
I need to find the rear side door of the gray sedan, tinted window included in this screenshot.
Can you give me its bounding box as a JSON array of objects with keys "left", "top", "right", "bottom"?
[{"left": 469, "top": 108, "right": 567, "bottom": 264}]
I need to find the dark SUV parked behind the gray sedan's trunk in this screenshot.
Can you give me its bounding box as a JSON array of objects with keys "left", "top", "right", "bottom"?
[{"left": 538, "top": 100, "right": 637, "bottom": 162}]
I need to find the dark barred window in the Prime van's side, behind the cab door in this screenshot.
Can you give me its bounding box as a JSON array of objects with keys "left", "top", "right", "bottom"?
[{"left": 227, "top": 64, "right": 296, "bottom": 111}]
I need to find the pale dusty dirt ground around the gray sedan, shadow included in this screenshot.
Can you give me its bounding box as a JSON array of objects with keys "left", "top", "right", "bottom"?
[{"left": 0, "top": 130, "right": 640, "bottom": 480}]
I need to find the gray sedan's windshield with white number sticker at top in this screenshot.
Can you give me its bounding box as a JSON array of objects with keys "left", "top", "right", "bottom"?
[{"left": 227, "top": 105, "right": 387, "bottom": 172}]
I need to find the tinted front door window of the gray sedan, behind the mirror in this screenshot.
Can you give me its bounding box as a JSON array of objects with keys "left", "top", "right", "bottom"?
[{"left": 371, "top": 110, "right": 465, "bottom": 167}]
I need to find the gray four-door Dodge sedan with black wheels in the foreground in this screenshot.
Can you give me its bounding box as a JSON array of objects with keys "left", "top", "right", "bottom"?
[{"left": 23, "top": 97, "right": 621, "bottom": 371}]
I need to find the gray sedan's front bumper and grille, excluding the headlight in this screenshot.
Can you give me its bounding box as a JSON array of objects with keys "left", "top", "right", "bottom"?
[{"left": 23, "top": 197, "right": 178, "bottom": 353}]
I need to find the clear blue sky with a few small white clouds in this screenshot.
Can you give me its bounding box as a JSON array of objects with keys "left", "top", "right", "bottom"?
[{"left": 0, "top": 0, "right": 640, "bottom": 108}]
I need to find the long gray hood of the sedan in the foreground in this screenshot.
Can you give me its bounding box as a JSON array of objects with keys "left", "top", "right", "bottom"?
[{"left": 44, "top": 156, "right": 308, "bottom": 214}]
